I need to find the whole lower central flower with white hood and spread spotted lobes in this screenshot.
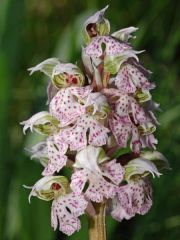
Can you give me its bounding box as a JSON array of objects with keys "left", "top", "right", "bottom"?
[{"left": 70, "top": 145, "right": 124, "bottom": 202}]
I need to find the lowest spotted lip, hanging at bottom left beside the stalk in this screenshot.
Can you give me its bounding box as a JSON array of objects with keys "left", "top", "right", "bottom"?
[{"left": 51, "top": 193, "right": 87, "bottom": 236}]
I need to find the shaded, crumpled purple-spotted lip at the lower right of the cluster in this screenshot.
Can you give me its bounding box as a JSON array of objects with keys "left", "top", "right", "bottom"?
[{"left": 111, "top": 178, "right": 152, "bottom": 221}]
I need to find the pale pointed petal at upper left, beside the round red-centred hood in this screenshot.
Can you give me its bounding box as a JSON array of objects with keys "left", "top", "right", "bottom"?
[{"left": 28, "top": 58, "right": 60, "bottom": 77}]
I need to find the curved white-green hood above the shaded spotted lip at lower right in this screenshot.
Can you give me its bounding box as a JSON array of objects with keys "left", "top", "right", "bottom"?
[{"left": 125, "top": 157, "right": 161, "bottom": 181}]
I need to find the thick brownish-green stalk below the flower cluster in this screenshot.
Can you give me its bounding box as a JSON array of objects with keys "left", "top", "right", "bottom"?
[{"left": 88, "top": 202, "right": 106, "bottom": 240}]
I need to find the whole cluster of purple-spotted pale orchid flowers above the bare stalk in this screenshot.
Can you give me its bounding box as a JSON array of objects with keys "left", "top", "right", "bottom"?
[{"left": 21, "top": 7, "right": 168, "bottom": 235}]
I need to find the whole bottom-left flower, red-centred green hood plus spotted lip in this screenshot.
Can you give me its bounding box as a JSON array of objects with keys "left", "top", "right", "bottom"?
[{"left": 26, "top": 176, "right": 87, "bottom": 236}]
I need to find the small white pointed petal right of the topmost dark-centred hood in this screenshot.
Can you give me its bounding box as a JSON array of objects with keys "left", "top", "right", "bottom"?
[{"left": 111, "top": 27, "right": 138, "bottom": 42}]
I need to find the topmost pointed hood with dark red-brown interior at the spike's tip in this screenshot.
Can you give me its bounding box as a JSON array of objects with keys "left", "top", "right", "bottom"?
[{"left": 83, "top": 6, "right": 110, "bottom": 43}]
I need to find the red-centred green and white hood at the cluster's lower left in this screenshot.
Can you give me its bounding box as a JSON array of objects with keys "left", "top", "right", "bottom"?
[{"left": 29, "top": 176, "right": 69, "bottom": 202}]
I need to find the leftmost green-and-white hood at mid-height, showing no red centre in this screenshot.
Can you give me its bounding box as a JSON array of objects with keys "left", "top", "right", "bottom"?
[{"left": 20, "top": 111, "right": 59, "bottom": 135}]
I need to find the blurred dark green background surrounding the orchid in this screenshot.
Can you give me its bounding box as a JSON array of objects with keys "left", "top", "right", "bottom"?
[{"left": 0, "top": 0, "right": 180, "bottom": 240}]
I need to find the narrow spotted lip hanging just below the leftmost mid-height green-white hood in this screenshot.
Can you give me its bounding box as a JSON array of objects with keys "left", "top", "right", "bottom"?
[{"left": 42, "top": 137, "right": 68, "bottom": 176}]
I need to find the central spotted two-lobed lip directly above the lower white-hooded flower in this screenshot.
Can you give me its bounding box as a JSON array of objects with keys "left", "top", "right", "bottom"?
[{"left": 60, "top": 115, "right": 109, "bottom": 151}]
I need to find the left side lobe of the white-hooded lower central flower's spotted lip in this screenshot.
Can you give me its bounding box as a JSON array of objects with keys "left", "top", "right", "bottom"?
[{"left": 70, "top": 170, "right": 88, "bottom": 194}]
